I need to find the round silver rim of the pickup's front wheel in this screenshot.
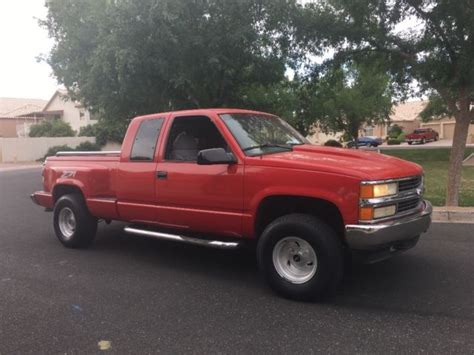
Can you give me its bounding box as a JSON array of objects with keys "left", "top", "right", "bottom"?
[{"left": 273, "top": 237, "right": 318, "bottom": 284}]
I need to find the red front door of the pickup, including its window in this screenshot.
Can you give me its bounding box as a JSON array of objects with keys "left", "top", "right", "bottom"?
[{"left": 155, "top": 114, "right": 244, "bottom": 237}]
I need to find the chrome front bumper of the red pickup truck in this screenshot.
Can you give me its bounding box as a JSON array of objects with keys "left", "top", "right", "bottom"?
[{"left": 346, "top": 200, "right": 433, "bottom": 251}]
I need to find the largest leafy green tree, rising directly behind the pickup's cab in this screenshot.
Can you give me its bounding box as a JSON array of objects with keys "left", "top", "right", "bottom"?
[{"left": 43, "top": 0, "right": 292, "bottom": 121}]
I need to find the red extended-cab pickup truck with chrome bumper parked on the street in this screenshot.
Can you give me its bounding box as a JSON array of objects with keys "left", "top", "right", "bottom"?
[{"left": 31, "top": 109, "right": 432, "bottom": 300}]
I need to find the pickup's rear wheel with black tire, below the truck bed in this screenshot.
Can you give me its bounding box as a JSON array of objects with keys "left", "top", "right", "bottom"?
[{"left": 53, "top": 194, "right": 97, "bottom": 248}]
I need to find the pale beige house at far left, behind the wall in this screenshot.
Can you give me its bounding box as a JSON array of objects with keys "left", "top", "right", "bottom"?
[{"left": 0, "top": 90, "right": 97, "bottom": 137}]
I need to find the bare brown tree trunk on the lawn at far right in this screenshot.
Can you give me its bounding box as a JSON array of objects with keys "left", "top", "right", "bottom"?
[{"left": 446, "top": 111, "right": 470, "bottom": 206}]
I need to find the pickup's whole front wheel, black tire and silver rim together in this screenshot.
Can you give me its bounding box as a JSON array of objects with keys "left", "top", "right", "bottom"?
[{"left": 257, "top": 214, "right": 344, "bottom": 301}]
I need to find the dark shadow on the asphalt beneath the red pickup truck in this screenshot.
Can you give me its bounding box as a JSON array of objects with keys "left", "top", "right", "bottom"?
[{"left": 93, "top": 224, "right": 469, "bottom": 314}]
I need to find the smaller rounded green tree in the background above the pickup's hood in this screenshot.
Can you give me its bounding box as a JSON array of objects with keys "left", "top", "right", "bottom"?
[{"left": 302, "top": 63, "right": 392, "bottom": 145}]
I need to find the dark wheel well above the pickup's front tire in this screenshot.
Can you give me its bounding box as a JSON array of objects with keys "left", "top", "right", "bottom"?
[{"left": 255, "top": 196, "right": 344, "bottom": 238}]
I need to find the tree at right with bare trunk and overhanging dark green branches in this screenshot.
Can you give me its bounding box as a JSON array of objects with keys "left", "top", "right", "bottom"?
[{"left": 294, "top": 0, "right": 474, "bottom": 205}]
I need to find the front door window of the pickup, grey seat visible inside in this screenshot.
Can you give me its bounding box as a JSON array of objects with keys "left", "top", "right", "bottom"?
[{"left": 165, "top": 116, "right": 229, "bottom": 162}]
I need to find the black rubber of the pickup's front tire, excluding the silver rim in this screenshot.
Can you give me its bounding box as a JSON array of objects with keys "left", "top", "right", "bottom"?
[{"left": 257, "top": 214, "right": 344, "bottom": 301}]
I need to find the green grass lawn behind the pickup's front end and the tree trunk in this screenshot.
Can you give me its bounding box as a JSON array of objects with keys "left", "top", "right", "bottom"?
[{"left": 382, "top": 148, "right": 474, "bottom": 206}]
